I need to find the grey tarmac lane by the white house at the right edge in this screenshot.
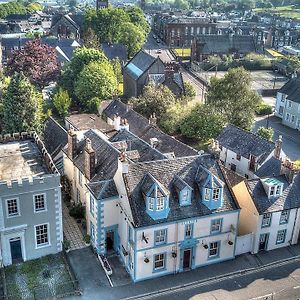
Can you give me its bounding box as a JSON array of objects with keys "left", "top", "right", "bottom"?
[{"left": 252, "top": 116, "right": 300, "bottom": 161}]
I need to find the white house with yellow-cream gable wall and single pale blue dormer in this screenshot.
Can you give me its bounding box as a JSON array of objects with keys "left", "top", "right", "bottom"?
[{"left": 227, "top": 158, "right": 300, "bottom": 253}]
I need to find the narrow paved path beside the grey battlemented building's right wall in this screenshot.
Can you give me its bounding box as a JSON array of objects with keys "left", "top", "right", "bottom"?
[{"left": 62, "top": 201, "right": 86, "bottom": 250}]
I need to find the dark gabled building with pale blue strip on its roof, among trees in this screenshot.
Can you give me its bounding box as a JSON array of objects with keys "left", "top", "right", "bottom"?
[{"left": 123, "top": 50, "right": 185, "bottom": 98}]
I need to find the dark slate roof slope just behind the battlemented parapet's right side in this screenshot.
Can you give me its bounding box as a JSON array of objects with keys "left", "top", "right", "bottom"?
[{"left": 43, "top": 117, "right": 68, "bottom": 158}]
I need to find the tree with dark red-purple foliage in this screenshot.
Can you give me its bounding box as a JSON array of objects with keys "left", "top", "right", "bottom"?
[{"left": 7, "top": 39, "right": 60, "bottom": 88}]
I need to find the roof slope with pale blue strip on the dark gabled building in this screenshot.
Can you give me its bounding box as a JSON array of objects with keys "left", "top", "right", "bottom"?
[{"left": 124, "top": 50, "right": 157, "bottom": 79}]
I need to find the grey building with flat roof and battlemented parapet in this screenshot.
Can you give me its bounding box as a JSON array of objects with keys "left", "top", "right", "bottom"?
[{"left": 0, "top": 132, "right": 63, "bottom": 266}]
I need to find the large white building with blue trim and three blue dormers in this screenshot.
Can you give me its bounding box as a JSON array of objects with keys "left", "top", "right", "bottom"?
[{"left": 64, "top": 113, "right": 239, "bottom": 282}]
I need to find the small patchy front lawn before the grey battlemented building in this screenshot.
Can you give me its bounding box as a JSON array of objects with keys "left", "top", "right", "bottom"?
[{"left": 4, "top": 254, "right": 76, "bottom": 300}]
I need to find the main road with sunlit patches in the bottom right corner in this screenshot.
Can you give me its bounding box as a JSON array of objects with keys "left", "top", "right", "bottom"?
[{"left": 136, "top": 261, "right": 300, "bottom": 300}]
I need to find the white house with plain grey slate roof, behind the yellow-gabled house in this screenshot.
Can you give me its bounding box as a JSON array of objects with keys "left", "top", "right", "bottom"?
[{"left": 216, "top": 124, "right": 286, "bottom": 178}]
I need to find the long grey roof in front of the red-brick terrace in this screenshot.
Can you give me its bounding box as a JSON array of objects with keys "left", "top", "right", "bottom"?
[{"left": 197, "top": 34, "right": 256, "bottom": 54}]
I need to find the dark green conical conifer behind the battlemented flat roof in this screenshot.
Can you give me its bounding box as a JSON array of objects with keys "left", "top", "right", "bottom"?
[{"left": 3, "top": 73, "right": 42, "bottom": 133}]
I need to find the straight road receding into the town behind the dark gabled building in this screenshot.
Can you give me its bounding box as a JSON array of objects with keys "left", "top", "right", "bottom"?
[{"left": 143, "top": 32, "right": 204, "bottom": 102}]
